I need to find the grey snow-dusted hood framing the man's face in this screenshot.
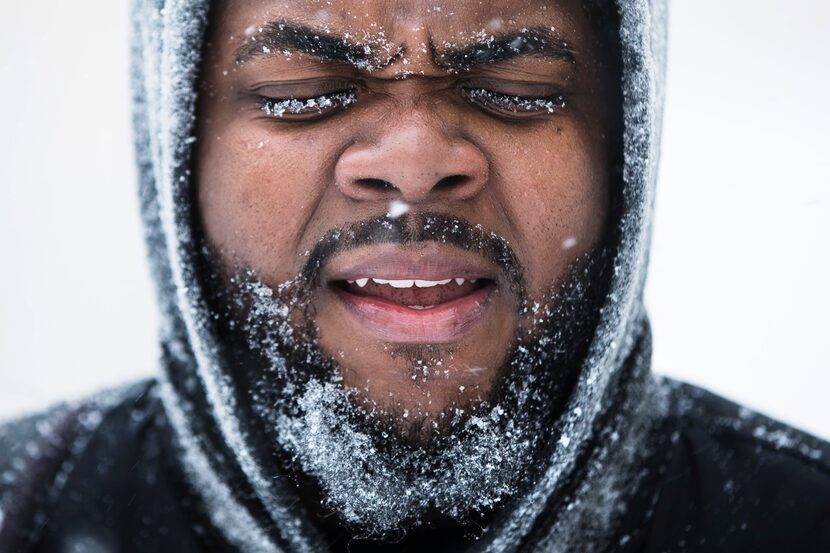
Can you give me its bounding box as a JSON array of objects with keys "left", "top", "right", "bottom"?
[{"left": 132, "top": 0, "right": 666, "bottom": 552}]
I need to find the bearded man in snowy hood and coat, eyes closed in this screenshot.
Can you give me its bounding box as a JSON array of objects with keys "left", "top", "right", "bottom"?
[{"left": 0, "top": 0, "right": 830, "bottom": 552}]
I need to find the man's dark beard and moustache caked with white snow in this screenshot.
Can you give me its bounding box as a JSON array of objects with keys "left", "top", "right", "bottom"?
[{"left": 202, "top": 214, "right": 608, "bottom": 538}]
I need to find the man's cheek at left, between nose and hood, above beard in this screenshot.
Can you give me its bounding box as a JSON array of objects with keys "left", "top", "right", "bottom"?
[{"left": 198, "top": 125, "right": 326, "bottom": 282}]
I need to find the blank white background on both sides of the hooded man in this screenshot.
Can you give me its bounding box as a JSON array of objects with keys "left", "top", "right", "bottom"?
[{"left": 0, "top": 0, "right": 830, "bottom": 438}]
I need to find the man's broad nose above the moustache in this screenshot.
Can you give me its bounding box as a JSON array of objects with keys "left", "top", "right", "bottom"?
[{"left": 335, "top": 120, "right": 489, "bottom": 203}]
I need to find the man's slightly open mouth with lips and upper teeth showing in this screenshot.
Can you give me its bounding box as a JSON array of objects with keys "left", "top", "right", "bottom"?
[{"left": 327, "top": 245, "right": 498, "bottom": 344}]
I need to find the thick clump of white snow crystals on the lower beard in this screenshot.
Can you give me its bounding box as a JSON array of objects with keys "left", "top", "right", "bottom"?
[{"left": 278, "top": 376, "right": 534, "bottom": 535}]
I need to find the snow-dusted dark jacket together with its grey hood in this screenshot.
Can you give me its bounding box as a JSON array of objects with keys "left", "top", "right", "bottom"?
[{"left": 0, "top": 0, "right": 830, "bottom": 553}]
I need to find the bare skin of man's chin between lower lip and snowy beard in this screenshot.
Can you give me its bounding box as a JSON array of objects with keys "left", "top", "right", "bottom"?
[{"left": 317, "top": 294, "right": 516, "bottom": 426}]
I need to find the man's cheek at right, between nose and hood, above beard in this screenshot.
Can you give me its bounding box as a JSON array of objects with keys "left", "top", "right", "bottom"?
[{"left": 496, "top": 129, "right": 608, "bottom": 295}]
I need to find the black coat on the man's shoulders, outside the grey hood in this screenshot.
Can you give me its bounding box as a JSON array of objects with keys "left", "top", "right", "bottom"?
[{"left": 0, "top": 382, "right": 830, "bottom": 553}]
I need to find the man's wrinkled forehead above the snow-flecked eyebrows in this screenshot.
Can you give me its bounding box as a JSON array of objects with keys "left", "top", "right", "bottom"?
[{"left": 214, "top": 0, "right": 588, "bottom": 51}]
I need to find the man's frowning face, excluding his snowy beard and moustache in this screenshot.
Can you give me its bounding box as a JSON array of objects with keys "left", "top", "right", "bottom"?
[{"left": 196, "top": 0, "right": 609, "bottom": 426}]
